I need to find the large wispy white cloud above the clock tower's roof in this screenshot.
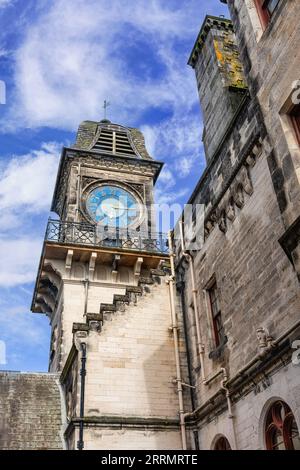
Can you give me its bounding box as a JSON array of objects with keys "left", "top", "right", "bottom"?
[{"left": 2, "top": 0, "right": 202, "bottom": 130}]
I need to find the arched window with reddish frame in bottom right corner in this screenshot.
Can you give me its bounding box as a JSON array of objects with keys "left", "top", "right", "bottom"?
[{"left": 265, "top": 401, "right": 300, "bottom": 450}]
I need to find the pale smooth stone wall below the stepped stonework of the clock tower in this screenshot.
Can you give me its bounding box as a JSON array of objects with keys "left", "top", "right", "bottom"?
[{"left": 65, "top": 277, "right": 190, "bottom": 449}]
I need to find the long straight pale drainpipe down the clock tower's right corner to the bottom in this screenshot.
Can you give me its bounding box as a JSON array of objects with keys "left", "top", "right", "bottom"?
[{"left": 167, "top": 232, "right": 187, "bottom": 450}]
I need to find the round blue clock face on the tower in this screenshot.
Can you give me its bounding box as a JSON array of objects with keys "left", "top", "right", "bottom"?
[{"left": 86, "top": 185, "right": 141, "bottom": 228}]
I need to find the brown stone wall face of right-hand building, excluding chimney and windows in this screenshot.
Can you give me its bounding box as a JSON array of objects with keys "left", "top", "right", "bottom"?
[{"left": 177, "top": 0, "right": 300, "bottom": 449}]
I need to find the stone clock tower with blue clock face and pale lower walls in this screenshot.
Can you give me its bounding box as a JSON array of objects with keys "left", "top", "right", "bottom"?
[{"left": 32, "top": 119, "right": 189, "bottom": 450}]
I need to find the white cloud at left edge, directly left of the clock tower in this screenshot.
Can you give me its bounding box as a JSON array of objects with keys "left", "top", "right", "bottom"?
[{"left": 0, "top": 142, "right": 61, "bottom": 287}]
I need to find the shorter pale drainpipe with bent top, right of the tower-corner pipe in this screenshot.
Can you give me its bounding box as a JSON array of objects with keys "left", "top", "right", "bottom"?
[{"left": 179, "top": 221, "right": 206, "bottom": 382}]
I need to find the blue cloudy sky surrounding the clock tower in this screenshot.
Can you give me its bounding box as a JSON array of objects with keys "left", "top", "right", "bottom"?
[{"left": 0, "top": 0, "right": 228, "bottom": 372}]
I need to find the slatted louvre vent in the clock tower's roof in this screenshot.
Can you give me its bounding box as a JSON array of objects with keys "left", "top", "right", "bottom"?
[{"left": 93, "top": 129, "right": 136, "bottom": 156}]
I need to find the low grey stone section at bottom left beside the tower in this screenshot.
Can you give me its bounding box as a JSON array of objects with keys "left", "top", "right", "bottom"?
[{"left": 0, "top": 372, "right": 64, "bottom": 450}]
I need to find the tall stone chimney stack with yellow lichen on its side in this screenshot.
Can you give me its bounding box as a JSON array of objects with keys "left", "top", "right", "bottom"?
[{"left": 188, "top": 16, "right": 247, "bottom": 163}]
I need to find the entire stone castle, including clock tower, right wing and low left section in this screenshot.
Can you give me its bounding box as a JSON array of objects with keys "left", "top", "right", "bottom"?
[{"left": 0, "top": 0, "right": 300, "bottom": 450}]
